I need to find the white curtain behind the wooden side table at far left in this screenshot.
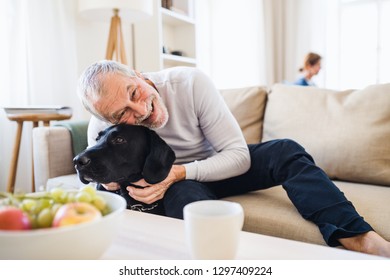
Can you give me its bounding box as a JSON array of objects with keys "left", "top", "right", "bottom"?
[{"left": 0, "top": 0, "right": 82, "bottom": 191}]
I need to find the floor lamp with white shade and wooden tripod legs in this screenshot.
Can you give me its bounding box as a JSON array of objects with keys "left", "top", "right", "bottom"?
[{"left": 79, "top": 0, "right": 153, "bottom": 64}]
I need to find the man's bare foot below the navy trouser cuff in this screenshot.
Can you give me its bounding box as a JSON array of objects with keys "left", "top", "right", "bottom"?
[{"left": 339, "top": 231, "right": 390, "bottom": 258}]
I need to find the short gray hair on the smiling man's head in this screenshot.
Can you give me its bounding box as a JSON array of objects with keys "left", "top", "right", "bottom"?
[{"left": 77, "top": 60, "right": 136, "bottom": 120}]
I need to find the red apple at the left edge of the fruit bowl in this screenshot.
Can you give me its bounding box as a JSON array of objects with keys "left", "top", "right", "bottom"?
[{"left": 0, "top": 206, "right": 31, "bottom": 230}]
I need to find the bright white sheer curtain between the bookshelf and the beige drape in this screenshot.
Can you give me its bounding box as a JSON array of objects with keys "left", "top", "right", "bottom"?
[{"left": 195, "top": 0, "right": 266, "bottom": 88}]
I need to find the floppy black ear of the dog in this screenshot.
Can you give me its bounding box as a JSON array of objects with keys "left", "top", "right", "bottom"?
[{"left": 142, "top": 130, "right": 176, "bottom": 184}]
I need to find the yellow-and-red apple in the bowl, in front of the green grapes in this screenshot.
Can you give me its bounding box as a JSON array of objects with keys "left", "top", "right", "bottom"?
[{"left": 52, "top": 202, "right": 102, "bottom": 227}]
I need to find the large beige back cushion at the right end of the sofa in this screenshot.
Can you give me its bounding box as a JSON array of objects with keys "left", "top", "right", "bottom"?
[{"left": 263, "top": 84, "right": 390, "bottom": 186}]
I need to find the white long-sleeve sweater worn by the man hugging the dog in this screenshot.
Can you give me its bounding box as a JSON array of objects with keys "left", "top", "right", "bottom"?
[{"left": 88, "top": 67, "right": 250, "bottom": 182}]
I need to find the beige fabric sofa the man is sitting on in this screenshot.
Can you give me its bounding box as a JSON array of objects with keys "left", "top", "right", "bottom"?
[{"left": 33, "top": 84, "right": 390, "bottom": 245}]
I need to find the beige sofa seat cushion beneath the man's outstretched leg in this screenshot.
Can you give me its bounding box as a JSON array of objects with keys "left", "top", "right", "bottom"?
[{"left": 224, "top": 181, "right": 390, "bottom": 245}]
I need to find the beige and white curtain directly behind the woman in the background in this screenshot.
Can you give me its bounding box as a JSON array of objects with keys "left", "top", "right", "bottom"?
[{"left": 263, "top": 0, "right": 330, "bottom": 86}]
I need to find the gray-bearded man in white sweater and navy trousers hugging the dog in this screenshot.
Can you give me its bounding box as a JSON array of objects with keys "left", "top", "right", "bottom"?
[{"left": 78, "top": 60, "right": 390, "bottom": 257}]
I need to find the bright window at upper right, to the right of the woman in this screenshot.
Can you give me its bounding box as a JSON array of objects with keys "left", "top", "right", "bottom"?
[{"left": 338, "top": 0, "right": 390, "bottom": 88}]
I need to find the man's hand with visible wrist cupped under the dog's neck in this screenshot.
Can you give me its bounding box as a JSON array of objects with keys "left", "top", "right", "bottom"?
[{"left": 127, "top": 165, "right": 186, "bottom": 204}]
